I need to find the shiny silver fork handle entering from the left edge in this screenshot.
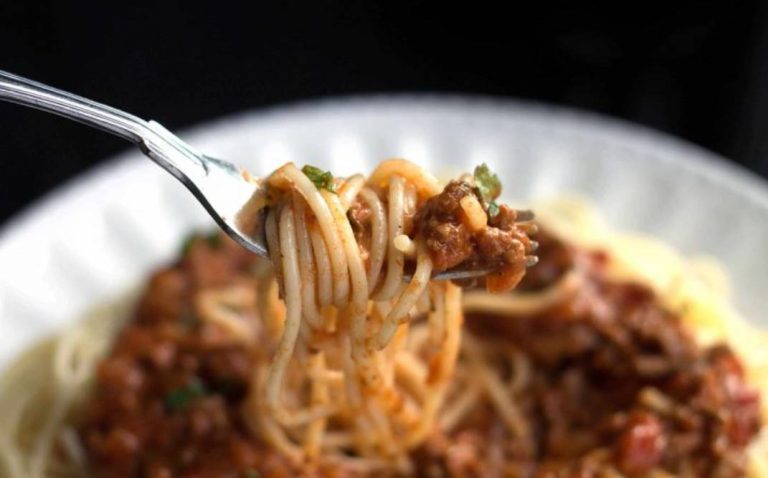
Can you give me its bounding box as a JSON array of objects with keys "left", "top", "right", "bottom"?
[{"left": 0, "top": 70, "right": 207, "bottom": 183}]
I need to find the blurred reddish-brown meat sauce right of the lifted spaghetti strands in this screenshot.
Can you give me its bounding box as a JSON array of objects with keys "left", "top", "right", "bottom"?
[{"left": 415, "top": 233, "right": 761, "bottom": 478}]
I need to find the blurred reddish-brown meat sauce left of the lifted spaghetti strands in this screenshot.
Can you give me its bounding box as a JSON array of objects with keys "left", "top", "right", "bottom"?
[{"left": 80, "top": 238, "right": 294, "bottom": 478}]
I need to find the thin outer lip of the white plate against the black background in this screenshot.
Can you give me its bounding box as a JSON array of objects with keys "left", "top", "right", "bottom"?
[{"left": 0, "top": 93, "right": 768, "bottom": 246}]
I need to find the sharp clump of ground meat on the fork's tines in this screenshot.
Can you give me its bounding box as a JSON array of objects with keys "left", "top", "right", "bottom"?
[{"left": 414, "top": 181, "right": 531, "bottom": 291}]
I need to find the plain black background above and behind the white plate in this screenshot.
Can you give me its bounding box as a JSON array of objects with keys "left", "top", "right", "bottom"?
[{"left": 0, "top": 0, "right": 768, "bottom": 223}]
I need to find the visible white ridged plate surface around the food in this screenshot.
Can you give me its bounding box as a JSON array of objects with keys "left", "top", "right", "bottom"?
[{"left": 0, "top": 96, "right": 768, "bottom": 367}]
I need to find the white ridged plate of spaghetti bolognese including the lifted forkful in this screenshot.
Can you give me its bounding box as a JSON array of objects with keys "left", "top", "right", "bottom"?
[{"left": 0, "top": 96, "right": 768, "bottom": 478}]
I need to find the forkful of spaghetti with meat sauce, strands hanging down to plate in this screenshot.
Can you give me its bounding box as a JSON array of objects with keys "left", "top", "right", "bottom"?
[{"left": 240, "top": 160, "right": 533, "bottom": 471}]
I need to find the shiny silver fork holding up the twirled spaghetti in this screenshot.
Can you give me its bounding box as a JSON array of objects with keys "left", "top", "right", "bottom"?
[{"left": 0, "top": 70, "right": 532, "bottom": 279}]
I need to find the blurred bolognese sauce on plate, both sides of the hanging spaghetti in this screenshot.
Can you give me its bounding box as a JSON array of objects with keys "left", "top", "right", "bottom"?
[{"left": 80, "top": 231, "right": 760, "bottom": 478}]
